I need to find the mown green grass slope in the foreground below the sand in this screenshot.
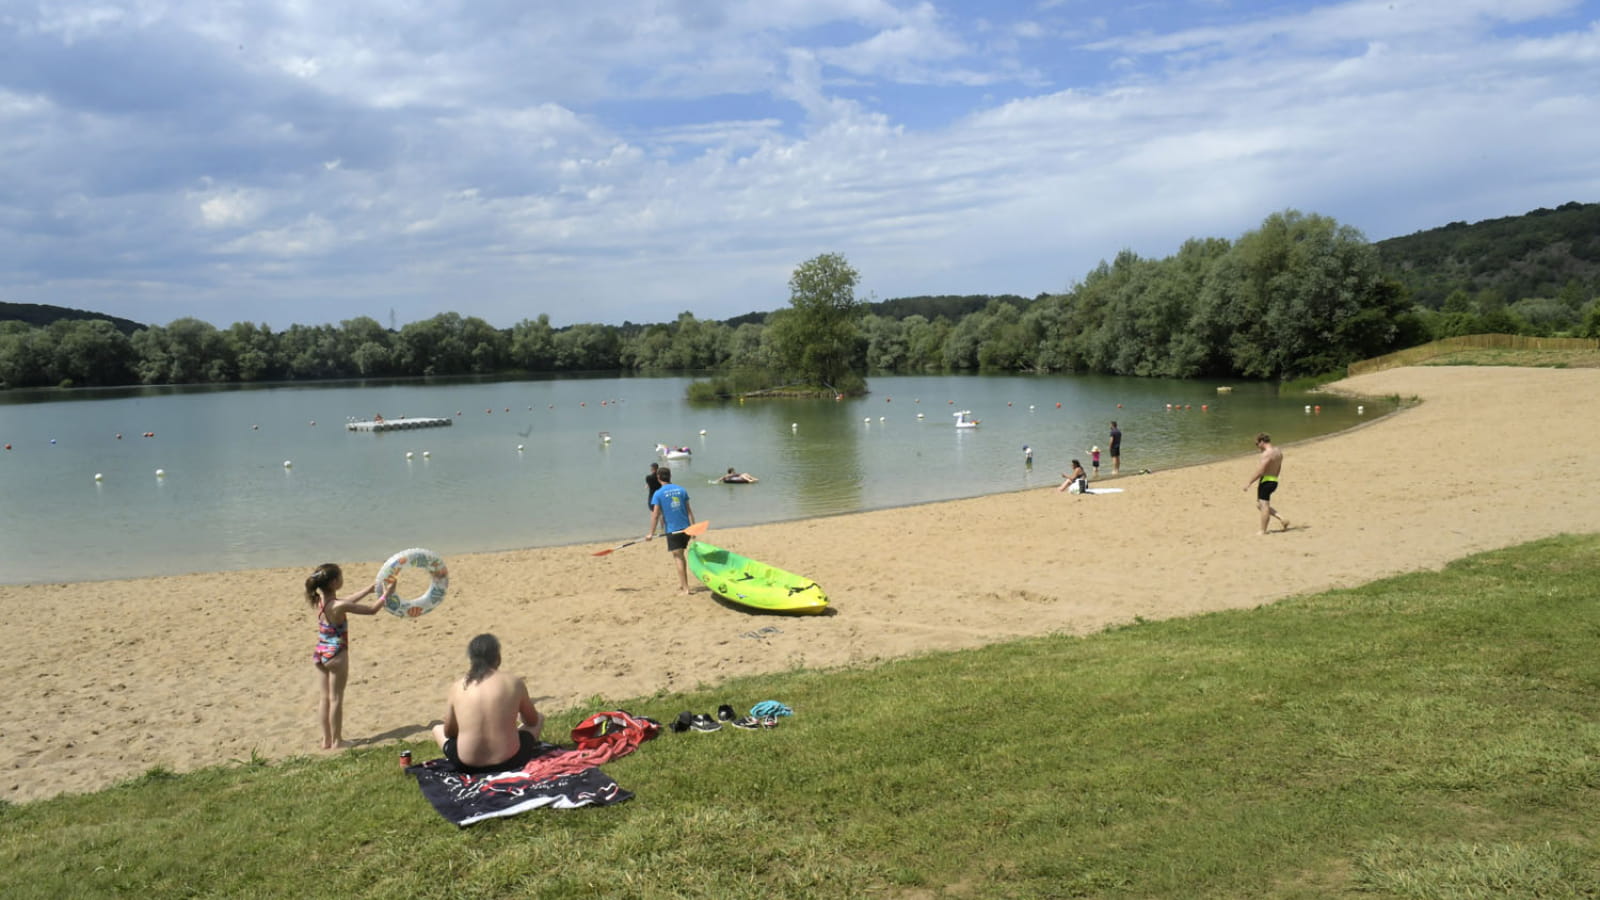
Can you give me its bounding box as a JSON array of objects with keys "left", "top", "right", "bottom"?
[{"left": 0, "top": 536, "right": 1600, "bottom": 900}]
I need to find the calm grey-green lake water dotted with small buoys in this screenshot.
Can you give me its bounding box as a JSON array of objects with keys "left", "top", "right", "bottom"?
[{"left": 0, "top": 376, "right": 1389, "bottom": 583}]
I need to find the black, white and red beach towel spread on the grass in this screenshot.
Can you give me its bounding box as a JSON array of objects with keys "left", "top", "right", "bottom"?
[{"left": 406, "top": 711, "right": 661, "bottom": 828}]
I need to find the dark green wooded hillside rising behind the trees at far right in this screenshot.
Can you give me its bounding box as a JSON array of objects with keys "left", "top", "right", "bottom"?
[{"left": 1374, "top": 202, "right": 1600, "bottom": 309}]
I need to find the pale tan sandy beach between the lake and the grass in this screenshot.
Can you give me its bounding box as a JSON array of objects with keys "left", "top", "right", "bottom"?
[{"left": 0, "top": 367, "right": 1600, "bottom": 802}]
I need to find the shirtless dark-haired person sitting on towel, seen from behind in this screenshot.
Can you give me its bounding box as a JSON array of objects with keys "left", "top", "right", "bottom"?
[{"left": 434, "top": 634, "right": 544, "bottom": 772}]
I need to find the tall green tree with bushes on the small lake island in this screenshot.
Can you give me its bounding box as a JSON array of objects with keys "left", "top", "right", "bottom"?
[{"left": 768, "top": 253, "right": 866, "bottom": 394}]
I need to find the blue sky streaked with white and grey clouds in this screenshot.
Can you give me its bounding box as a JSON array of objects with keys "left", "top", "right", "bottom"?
[{"left": 0, "top": 0, "right": 1600, "bottom": 330}]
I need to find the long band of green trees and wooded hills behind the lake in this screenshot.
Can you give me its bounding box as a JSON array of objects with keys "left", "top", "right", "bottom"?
[{"left": 0, "top": 203, "right": 1600, "bottom": 388}]
